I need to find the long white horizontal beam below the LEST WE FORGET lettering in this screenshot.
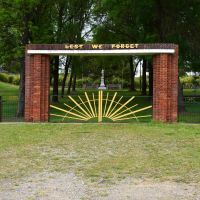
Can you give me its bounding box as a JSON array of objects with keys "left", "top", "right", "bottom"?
[{"left": 27, "top": 49, "right": 175, "bottom": 56}]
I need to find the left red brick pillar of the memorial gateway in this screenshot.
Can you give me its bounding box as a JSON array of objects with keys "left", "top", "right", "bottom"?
[{"left": 25, "top": 55, "right": 50, "bottom": 122}]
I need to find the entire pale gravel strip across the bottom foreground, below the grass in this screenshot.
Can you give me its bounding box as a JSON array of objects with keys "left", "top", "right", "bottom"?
[{"left": 0, "top": 172, "right": 200, "bottom": 200}]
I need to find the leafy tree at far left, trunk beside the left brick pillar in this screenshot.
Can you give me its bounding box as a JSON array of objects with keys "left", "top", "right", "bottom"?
[{"left": 0, "top": 0, "right": 51, "bottom": 116}]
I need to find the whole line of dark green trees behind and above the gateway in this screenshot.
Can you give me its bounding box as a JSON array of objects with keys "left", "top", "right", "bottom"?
[{"left": 0, "top": 0, "right": 200, "bottom": 116}]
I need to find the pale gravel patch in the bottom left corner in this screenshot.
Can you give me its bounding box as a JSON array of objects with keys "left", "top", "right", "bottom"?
[{"left": 0, "top": 173, "right": 86, "bottom": 200}]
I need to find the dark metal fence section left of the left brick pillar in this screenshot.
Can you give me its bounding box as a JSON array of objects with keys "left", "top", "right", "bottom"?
[{"left": 0, "top": 96, "right": 24, "bottom": 122}]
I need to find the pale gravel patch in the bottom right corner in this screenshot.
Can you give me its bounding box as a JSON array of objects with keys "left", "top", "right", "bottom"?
[{"left": 95, "top": 179, "right": 200, "bottom": 200}]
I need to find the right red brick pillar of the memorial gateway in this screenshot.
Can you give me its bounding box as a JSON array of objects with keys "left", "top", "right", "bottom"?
[{"left": 153, "top": 48, "right": 178, "bottom": 122}]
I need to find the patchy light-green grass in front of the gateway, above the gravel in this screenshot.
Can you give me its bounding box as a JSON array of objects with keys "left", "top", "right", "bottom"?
[{"left": 0, "top": 123, "right": 200, "bottom": 182}]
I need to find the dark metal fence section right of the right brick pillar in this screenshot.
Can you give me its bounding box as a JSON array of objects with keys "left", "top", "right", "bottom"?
[{"left": 178, "top": 95, "right": 200, "bottom": 123}]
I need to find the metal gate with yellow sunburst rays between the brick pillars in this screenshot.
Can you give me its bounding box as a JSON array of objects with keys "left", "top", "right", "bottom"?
[{"left": 49, "top": 90, "right": 152, "bottom": 123}]
